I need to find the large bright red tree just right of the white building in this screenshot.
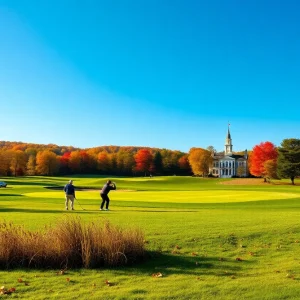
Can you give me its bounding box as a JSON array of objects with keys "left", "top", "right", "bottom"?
[{"left": 250, "top": 142, "right": 278, "bottom": 181}]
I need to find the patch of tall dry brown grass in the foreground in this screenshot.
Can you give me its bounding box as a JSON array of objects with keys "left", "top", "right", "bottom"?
[{"left": 0, "top": 217, "right": 145, "bottom": 269}]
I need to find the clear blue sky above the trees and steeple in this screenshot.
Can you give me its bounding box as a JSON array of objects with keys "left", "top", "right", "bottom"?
[{"left": 0, "top": 0, "right": 300, "bottom": 152}]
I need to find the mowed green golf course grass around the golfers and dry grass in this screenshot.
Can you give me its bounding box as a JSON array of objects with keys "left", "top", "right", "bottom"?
[{"left": 0, "top": 176, "right": 300, "bottom": 299}]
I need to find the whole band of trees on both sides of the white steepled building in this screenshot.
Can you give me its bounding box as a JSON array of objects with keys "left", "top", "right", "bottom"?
[{"left": 0, "top": 139, "right": 300, "bottom": 184}]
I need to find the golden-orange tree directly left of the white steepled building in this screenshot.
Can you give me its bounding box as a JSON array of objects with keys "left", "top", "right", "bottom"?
[{"left": 188, "top": 148, "right": 212, "bottom": 177}]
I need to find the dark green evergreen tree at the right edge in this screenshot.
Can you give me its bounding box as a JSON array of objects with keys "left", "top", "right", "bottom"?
[{"left": 277, "top": 139, "right": 300, "bottom": 184}]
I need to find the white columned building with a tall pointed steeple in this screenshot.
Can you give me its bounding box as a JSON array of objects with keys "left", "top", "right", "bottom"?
[{"left": 210, "top": 126, "right": 249, "bottom": 178}]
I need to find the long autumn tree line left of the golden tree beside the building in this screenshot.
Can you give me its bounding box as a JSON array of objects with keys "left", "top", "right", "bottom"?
[{"left": 0, "top": 141, "right": 192, "bottom": 176}]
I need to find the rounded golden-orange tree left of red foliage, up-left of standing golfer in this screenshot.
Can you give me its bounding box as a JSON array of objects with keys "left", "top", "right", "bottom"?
[{"left": 36, "top": 150, "right": 59, "bottom": 176}]
